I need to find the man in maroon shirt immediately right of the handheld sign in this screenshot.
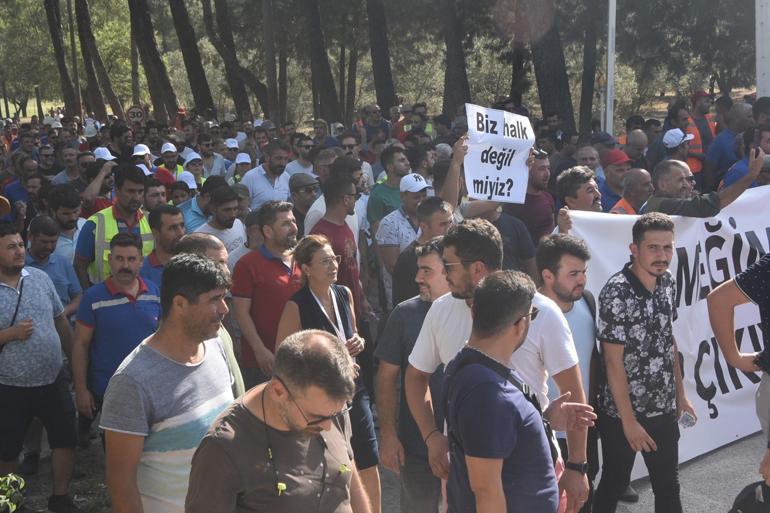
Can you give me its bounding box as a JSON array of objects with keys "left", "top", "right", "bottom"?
[{"left": 503, "top": 152, "right": 555, "bottom": 246}]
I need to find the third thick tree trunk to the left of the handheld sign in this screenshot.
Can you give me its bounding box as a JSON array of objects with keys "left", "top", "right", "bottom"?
[{"left": 302, "top": 0, "right": 342, "bottom": 123}]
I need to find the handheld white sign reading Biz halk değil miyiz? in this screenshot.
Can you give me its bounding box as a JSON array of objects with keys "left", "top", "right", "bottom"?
[{"left": 463, "top": 103, "right": 535, "bottom": 203}]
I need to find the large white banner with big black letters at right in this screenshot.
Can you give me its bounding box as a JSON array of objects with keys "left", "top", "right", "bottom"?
[{"left": 570, "top": 187, "right": 770, "bottom": 468}]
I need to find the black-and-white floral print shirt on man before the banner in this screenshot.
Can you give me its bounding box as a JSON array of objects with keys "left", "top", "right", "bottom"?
[{"left": 597, "top": 263, "right": 676, "bottom": 418}]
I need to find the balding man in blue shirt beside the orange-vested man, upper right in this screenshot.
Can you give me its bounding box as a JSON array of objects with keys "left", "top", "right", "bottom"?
[{"left": 703, "top": 103, "right": 754, "bottom": 192}]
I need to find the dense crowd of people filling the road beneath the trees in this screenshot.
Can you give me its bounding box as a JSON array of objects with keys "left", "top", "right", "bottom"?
[{"left": 0, "top": 91, "right": 770, "bottom": 513}]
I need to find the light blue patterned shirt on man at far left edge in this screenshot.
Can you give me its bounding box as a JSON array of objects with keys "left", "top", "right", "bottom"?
[{"left": 0, "top": 267, "right": 64, "bottom": 387}]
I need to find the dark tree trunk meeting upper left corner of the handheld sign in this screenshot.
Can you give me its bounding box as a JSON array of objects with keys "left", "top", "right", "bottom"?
[{"left": 439, "top": 0, "right": 471, "bottom": 116}]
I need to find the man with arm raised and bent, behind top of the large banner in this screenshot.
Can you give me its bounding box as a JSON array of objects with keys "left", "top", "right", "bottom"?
[{"left": 641, "top": 146, "right": 765, "bottom": 217}]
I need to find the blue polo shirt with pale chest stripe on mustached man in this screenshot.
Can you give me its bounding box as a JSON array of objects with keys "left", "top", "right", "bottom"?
[{"left": 77, "top": 277, "right": 160, "bottom": 396}]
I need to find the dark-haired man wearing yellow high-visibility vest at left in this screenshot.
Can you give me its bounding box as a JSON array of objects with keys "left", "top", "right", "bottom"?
[{"left": 75, "top": 164, "right": 154, "bottom": 289}]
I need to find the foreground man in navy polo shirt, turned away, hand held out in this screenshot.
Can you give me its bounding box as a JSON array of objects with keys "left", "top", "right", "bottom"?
[{"left": 438, "top": 271, "right": 595, "bottom": 513}]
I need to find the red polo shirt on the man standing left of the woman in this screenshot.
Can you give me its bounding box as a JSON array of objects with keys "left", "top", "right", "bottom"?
[{"left": 231, "top": 244, "right": 302, "bottom": 369}]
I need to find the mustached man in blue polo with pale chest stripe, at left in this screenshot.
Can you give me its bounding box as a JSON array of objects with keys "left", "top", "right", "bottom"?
[{"left": 72, "top": 233, "right": 160, "bottom": 448}]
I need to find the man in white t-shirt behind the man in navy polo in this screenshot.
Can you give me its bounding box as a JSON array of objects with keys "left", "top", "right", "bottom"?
[{"left": 405, "top": 219, "right": 588, "bottom": 503}]
